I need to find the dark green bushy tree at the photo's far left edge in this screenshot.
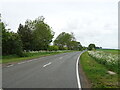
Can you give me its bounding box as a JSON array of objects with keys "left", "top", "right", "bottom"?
[{"left": 1, "top": 23, "right": 23, "bottom": 56}]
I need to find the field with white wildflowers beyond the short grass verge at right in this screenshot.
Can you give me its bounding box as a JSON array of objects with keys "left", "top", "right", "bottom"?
[{"left": 88, "top": 49, "right": 119, "bottom": 72}]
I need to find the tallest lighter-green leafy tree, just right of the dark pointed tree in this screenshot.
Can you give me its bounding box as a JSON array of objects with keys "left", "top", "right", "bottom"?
[{"left": 25, "top": 16, "right": 54, "bottom": 50}]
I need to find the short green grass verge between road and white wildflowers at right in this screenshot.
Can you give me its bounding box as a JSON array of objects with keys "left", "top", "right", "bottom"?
[{"left": 80, "top": 52, "right": 118, "bottom": 88}]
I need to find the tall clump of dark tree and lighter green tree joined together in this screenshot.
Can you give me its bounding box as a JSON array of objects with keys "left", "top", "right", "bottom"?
[{"left": 18, "top": 16, "right": 54, "bottom": 51}]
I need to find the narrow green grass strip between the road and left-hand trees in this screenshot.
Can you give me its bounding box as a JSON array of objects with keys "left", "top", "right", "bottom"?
[{"left": 0, "top": 51, "right": 73, "bottom": 64}]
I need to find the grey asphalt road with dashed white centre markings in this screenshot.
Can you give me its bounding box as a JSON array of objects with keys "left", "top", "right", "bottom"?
[{"left": 2, "top": 52, "right": 81, "bottom": 88}]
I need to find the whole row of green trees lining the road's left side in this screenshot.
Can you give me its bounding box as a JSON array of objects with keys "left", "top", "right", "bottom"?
[{"left": 0, "top": 16, "right": 86, "bottom": 56}]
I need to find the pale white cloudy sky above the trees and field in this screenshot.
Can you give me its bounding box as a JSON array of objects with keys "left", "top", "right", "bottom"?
[{"left": 0, "top": 0, "right": 119, "bottom": 48}]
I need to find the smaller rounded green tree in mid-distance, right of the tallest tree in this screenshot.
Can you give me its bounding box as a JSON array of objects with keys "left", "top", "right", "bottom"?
[{"left": 54, "top": 32, "right": 82, "bottom": 50}]
